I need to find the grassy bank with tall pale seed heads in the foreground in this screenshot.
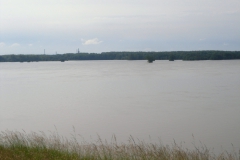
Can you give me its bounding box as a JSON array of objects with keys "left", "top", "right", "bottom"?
[{"left": 0, "top": 131, "right": 239, "bottom": 160}]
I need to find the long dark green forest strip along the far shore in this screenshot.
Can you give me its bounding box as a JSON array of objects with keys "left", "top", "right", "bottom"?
[{"left": 0, "top": 50, "right": 240, "bottom": 62}]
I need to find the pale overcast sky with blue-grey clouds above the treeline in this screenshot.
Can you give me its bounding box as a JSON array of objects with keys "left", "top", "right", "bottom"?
[{"left": 0, "top": 0, "right": 240, "bottom": 55}]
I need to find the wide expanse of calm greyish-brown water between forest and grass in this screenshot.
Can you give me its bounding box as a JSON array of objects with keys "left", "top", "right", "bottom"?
[{"left": 0, "top": 60, "right": 240, "bottom": 150}]
